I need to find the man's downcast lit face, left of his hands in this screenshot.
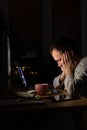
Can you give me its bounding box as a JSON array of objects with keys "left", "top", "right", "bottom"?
[{"left": 52, "top": 49, "right": 63, "bottom": 69}]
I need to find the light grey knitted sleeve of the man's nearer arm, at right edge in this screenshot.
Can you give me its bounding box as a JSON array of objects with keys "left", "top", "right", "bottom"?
[{"left": 64, "top": 64, "right": 87, "bottom": 96}]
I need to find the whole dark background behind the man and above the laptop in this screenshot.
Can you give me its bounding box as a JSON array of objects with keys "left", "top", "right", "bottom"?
[{"left": 0, "top": 0, "right": 87, "bottom": 86}]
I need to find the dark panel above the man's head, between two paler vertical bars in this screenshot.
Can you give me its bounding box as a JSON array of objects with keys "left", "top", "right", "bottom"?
[{"left": 52, "top": 0, "right": 81, "bottom": 48}]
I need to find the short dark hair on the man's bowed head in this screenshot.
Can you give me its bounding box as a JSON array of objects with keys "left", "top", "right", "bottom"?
[{"left": 49, "top": 36, "right": 79, "bottom": 54}]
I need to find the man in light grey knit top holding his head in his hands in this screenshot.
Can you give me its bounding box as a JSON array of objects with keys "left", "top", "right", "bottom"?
[{"left": 50, "top": 37, "right": 87, "bottom": 97}]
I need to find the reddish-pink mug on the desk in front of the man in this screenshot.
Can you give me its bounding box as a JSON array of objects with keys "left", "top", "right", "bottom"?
[{"left": 35, "top": 83, "right": 49, "bottom": 95}]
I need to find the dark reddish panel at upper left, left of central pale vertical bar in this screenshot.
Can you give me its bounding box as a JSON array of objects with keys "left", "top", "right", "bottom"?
[{"left": 9, "top": 0, "right": 42, "bottom": 61}]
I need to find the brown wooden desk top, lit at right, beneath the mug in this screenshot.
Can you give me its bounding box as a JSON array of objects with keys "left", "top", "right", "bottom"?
[{"left": 0, "top": 89, "right": 87, "bottom": 111}]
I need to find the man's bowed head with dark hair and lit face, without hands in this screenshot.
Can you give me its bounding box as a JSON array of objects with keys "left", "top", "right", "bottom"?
[{"left": 50, "top": 37, "right": 78, "bottom": 69}]
